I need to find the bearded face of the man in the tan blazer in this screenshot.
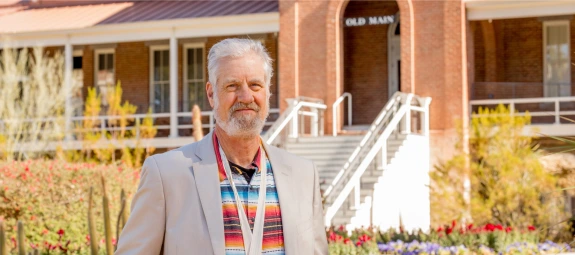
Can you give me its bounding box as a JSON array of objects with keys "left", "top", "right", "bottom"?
[{"left": 206, "top": 54, "right": 269, "bottom": 137}]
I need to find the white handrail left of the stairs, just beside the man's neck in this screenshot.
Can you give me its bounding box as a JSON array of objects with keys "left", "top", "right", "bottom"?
[{"left": 262, "top": 97, "right": 327, "bottom": 144}]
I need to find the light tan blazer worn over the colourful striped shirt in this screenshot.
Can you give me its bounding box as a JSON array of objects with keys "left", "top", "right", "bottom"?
[{"left": 116, "top": 134, "right": 327, "bottom": 255}]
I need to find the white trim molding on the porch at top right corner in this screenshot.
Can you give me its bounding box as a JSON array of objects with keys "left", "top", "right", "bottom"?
[{"left": 464, "top": 0, "right": 575, "bottom": 20}]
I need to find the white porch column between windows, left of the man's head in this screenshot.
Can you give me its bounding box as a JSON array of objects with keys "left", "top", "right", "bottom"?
[{"left": 170, "top": 30, "right": 178, "bottom": 137}]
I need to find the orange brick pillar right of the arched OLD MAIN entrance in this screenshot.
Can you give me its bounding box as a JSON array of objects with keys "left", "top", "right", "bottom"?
[{"left": 408, "top": 1, "right": 469, "bottom": 165}]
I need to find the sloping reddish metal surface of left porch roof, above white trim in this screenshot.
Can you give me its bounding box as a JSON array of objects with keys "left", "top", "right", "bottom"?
[{"left": 0, "top": 0, "right": 278, "bottom": 35}]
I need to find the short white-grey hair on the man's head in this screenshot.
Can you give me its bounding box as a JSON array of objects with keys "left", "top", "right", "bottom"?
[{"left": 208, "top": 38, "right": 273, "bottom": 90}]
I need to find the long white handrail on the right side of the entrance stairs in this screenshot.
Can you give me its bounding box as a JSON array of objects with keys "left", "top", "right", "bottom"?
[{"left": 324, "top": 92, "right": 431, "bottom": 225}]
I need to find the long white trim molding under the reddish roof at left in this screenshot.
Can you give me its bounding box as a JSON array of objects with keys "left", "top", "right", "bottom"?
[{"left": 0, "top": 12, "right": 280, "bottom": 48}]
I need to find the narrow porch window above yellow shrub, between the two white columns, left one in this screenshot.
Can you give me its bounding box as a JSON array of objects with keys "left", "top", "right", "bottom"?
[{"left": 94, "top": 49, "right": 116, "bottom": 106}]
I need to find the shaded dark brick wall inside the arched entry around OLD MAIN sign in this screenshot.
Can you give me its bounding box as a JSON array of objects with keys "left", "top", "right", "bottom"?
[{"left": 343, "top": 1, "right": 399, "bottom": 124}]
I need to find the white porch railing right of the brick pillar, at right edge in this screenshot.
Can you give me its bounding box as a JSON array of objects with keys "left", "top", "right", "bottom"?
[{"left": 469, "top": 97, "right": 575, "bottom": 124}]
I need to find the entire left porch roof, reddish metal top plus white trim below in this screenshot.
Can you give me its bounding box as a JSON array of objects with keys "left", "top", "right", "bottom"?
[{"left": 0, "top": 0, "right": 279, "bottom": 48}]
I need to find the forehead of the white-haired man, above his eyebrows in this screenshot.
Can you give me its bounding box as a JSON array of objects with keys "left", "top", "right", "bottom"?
[{"left": 217, "top": 54, "right": 265, "bottom": 81}]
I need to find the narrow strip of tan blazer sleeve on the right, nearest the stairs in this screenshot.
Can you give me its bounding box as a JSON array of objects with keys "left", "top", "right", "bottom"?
[{"left": 313, "top": 164, "right": 328, "bottom": 255}]
